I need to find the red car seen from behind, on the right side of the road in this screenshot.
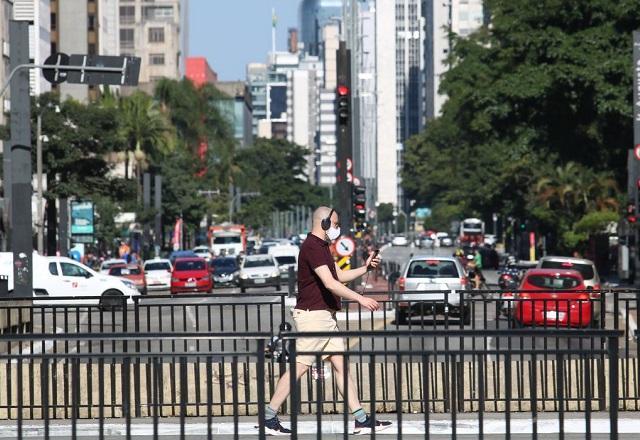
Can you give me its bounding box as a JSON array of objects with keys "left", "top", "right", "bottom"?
[{"left": 512, "top": 269, "right": 599, "bottom": 327}]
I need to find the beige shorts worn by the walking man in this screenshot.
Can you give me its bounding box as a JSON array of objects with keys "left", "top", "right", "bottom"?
[{"left": 293, "top": 309, "right": 344, "bottom": 366}]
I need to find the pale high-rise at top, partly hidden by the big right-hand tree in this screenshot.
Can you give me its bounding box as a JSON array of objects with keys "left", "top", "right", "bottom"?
[{"left": 422, "top": 0, "right": 487, "bottom": 121}]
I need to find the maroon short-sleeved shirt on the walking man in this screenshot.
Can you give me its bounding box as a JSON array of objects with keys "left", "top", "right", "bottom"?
[{"left": 296, "top": 233, "right": 340, "bottom": 310}]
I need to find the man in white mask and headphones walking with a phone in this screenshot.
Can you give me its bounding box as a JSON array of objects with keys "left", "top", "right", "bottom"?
[{"left": 264, "top": 206, "right": 391, "bottom": 435}]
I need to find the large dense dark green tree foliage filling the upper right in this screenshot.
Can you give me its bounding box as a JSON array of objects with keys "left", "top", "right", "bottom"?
[{"left": 403, "top": 0, "right": 640, "bottom": 249}]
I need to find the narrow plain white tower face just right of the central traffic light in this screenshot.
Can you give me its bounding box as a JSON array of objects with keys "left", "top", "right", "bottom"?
[{"left": 375, "top": 1, "right": 398, "bottom": 205}]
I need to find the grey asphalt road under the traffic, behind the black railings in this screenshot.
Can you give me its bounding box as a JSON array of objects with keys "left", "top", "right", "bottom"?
[{"left": 13, "top": 246, "right": 638, "bottom": 357}]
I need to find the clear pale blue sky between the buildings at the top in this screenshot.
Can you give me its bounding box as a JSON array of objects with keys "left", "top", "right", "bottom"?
[{"left": 189, "top": 0, "right": 300, "bottom": 81}]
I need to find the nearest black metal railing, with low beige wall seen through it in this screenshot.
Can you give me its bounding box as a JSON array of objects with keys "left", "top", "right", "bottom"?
[{"left": 0, "top": 329, "right": 624, "bottom": 438}]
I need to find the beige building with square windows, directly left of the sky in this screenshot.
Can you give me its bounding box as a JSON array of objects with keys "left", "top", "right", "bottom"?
[{"left": 119, "top": 0, "right": 189, "bottom": 92}]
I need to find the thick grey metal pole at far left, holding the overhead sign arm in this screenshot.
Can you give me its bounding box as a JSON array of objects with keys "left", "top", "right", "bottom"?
[{"left": 5, "top": 20, "right": 33, "bottom": 297}]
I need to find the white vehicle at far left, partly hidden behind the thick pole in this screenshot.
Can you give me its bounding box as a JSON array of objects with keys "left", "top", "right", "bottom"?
[{"left": 0, "top": 252, "right": 140, "bottom": 306}]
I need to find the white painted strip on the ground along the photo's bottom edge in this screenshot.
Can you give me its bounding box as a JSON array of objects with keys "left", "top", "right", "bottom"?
[{"left": 0, "top": 414, "right": 640, "bottom": 438}]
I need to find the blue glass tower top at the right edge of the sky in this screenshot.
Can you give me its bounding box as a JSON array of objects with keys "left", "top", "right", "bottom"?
[{"left": 299, "top": 0, "right": 342, "bottom": 56}]
